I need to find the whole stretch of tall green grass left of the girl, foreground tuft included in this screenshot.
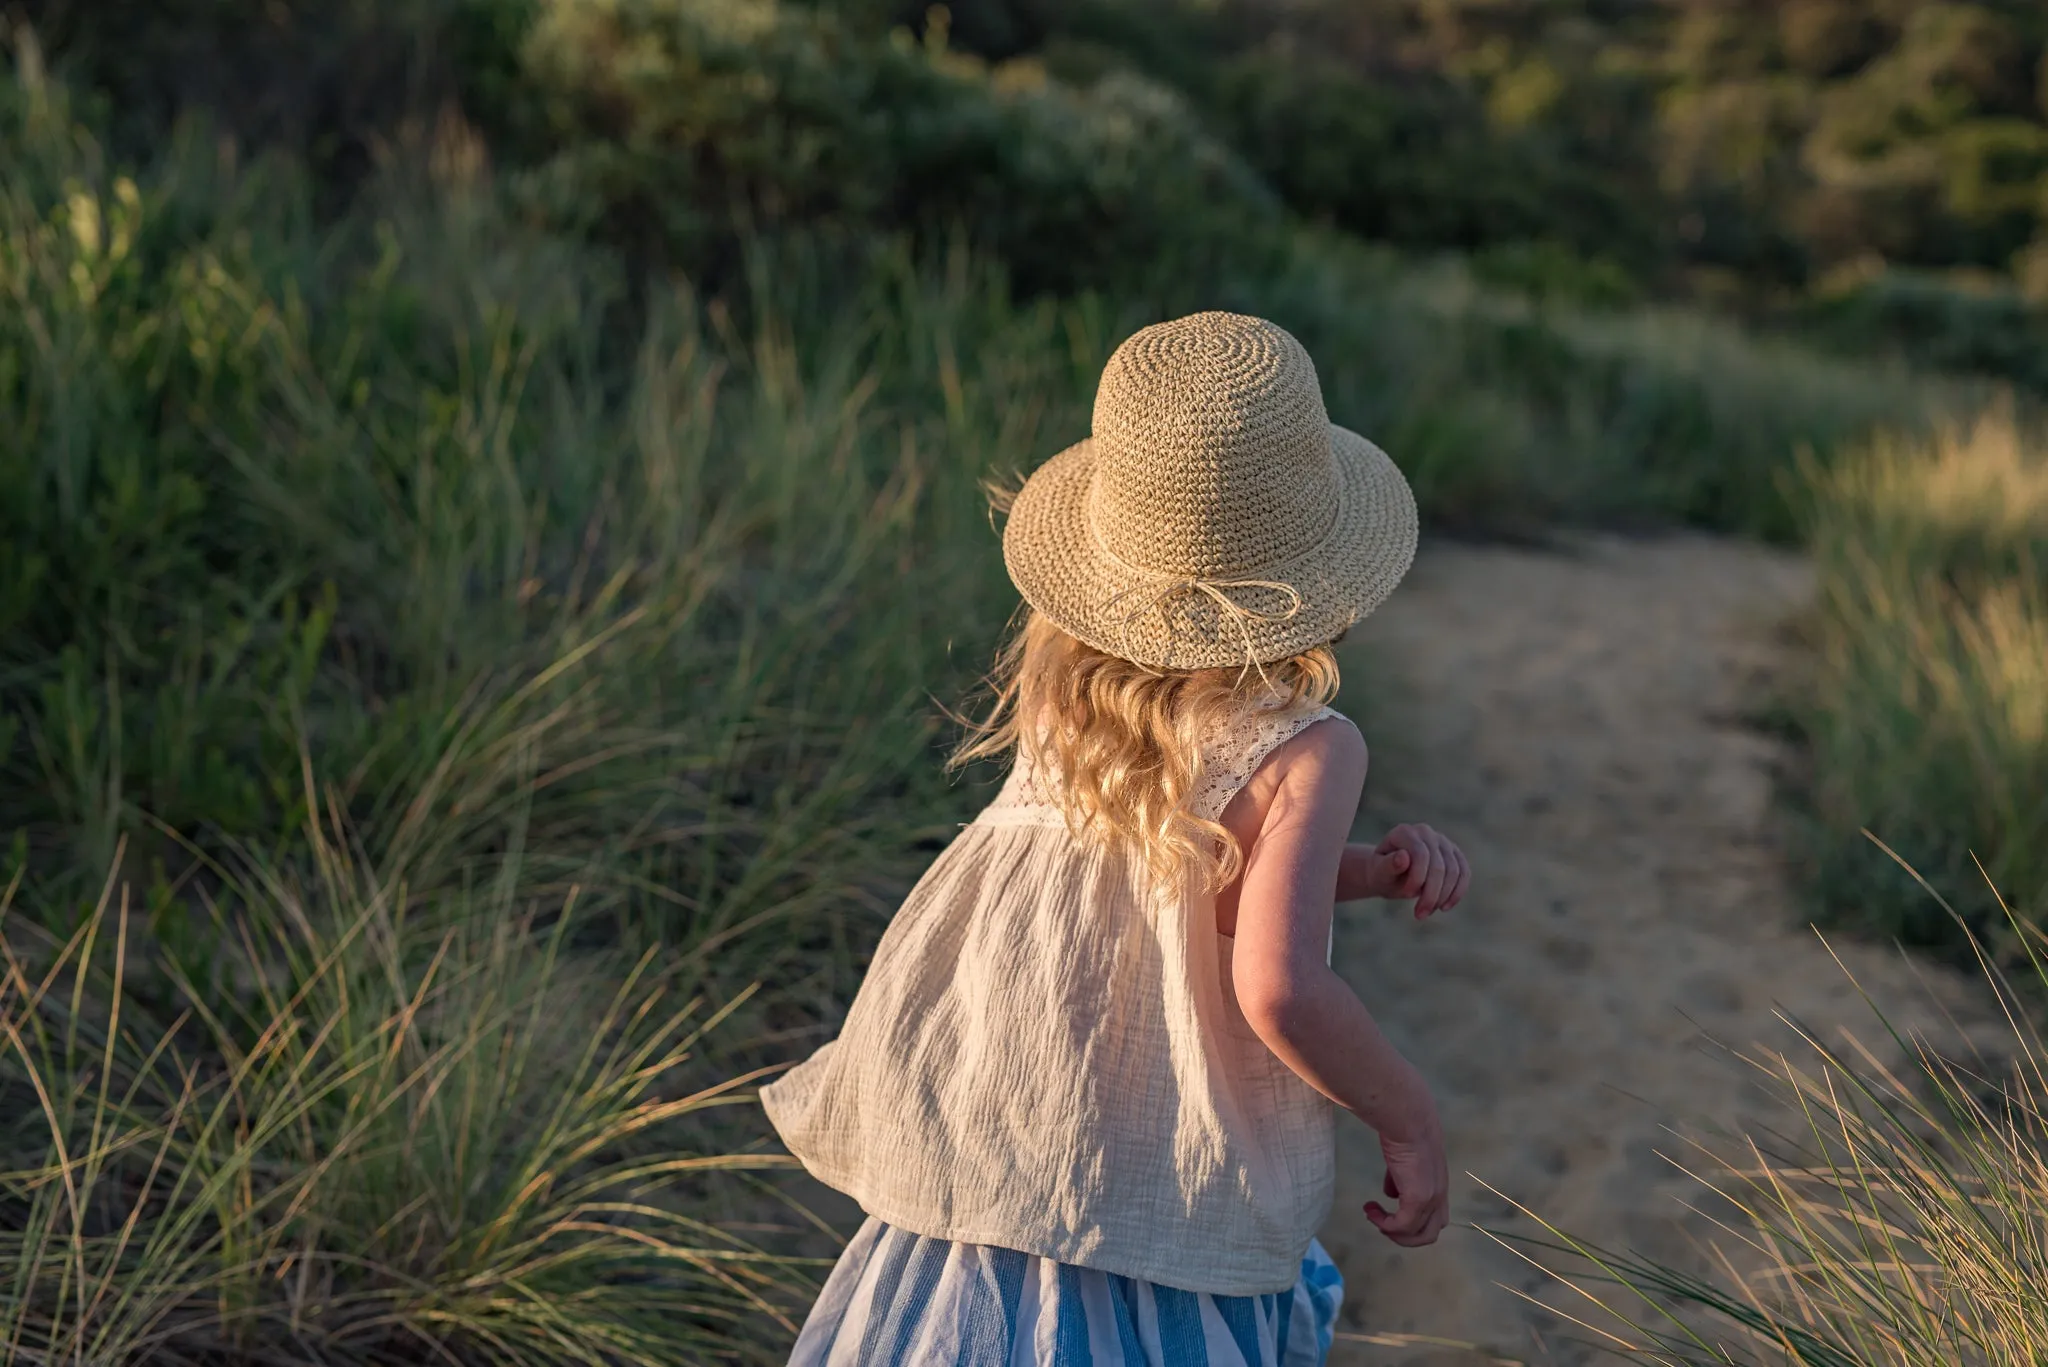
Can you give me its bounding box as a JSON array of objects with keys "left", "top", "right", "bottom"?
[{"left": 0, "top": 58, "right": 1073, "bottom": 1363}]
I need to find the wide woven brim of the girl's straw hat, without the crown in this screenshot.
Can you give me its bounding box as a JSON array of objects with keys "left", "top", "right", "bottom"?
[{"left": 1004, "top": 424, "right": 1417, "bottom": 670}]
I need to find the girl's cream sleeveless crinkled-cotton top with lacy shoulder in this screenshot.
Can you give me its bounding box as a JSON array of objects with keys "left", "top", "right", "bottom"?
[{"left": 762, "top": 705, "right": 1339, "bottom": 1295}]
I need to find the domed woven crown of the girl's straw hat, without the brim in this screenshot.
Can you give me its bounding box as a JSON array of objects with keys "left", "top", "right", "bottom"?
[{"left": 1090, "top": 314, "right": 1337, "bottom": 578}]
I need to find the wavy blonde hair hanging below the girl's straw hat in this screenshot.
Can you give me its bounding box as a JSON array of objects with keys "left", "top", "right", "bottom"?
[{"left": 950, "top": 607, "right": 1337, "bottom": 889}]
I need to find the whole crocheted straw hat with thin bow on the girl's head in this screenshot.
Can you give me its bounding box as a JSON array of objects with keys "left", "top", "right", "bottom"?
[{"left": 1004, "top": 314, "right": 1415, "bottom": 670}]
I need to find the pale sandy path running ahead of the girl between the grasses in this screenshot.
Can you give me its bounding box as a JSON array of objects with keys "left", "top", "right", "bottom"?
[{"left": 1323, "top": 537, "right": 1982, "bottom": 1365}]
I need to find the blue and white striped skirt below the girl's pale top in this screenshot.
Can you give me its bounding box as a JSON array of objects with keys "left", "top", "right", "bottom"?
[{"left": 788, "top": 1215, "right": 1343, "bottom": 1367}]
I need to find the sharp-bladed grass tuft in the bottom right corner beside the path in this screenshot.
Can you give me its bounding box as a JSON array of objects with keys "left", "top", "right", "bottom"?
[{"left": 1497, "top": 848, "right": 2048, "bottom": 1367}]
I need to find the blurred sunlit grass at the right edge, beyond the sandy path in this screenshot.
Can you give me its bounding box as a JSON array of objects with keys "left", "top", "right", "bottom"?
[{"left": 1804, "top": 410, "right": 2048, "bottom": 957}]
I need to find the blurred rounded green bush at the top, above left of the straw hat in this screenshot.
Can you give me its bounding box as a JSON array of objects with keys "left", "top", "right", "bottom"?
[{"left": 481, "top": 0, "right": 1276, "bottom": 291}]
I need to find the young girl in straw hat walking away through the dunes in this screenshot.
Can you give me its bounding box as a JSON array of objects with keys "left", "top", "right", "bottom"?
[{"left": 762, "top": 314, "right": 1468, "bottom": 1367}]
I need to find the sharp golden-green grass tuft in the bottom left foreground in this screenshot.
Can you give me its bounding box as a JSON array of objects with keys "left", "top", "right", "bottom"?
[{"left": 0, "top": 827, "right": 815, "bottom": 1365}]
